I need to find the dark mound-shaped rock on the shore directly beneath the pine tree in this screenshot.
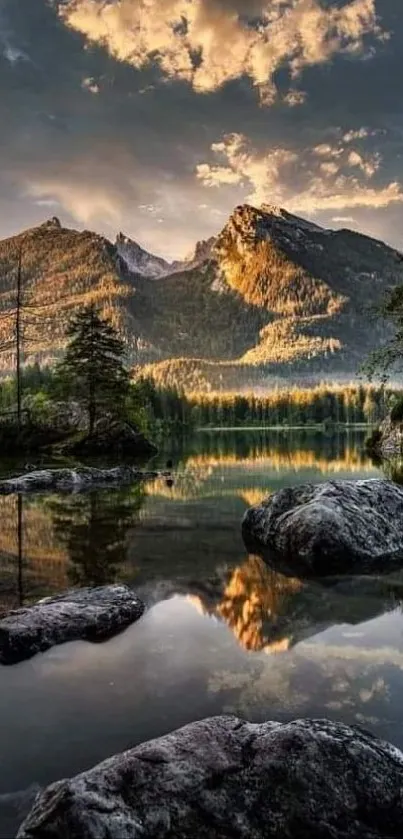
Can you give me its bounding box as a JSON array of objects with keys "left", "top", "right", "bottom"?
[{"left": 64, "top": 418, "right": 157, "bottom": 457}]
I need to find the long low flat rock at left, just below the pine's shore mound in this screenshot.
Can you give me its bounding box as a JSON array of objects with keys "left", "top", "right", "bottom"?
[{"left": 0, "top": 466, "right": 158, "bottom": 495}]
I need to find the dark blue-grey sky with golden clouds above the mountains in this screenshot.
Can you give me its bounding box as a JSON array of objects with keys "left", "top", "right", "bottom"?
[{"left": 0, "top": 0, "right": 403, "bottom": 258}]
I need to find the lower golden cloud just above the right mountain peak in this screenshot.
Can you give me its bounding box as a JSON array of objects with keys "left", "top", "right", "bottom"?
[{"left": 196, "top": 134, "right": 403, "bottom": 214}]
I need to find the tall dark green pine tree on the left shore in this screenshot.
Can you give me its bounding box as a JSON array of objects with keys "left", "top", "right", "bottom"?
[{"left": 58, "top": 305, "right": 129, "bottom": 434}]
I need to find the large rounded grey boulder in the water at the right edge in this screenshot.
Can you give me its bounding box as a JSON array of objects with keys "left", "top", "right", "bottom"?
[{"left": 242, "top": 479, "right": 403, "bottom": 576}]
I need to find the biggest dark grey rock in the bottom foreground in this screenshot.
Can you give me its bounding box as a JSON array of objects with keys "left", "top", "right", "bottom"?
[{"left": 17, "top": 717, "right": 403, "bottom": 839}]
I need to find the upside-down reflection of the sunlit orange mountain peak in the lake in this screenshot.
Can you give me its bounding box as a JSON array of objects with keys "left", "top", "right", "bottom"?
[{"left": 187, "top": 556, "right": 403, "bottom": 654}]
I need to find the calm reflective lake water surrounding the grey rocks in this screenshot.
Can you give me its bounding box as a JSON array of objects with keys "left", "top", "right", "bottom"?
[{"left": 0, "top": 431, "right": 403, "bottom": 837}]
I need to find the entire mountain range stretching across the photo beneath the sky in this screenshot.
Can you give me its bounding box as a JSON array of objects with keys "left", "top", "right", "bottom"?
[{"left": 0, "top": 205, "right": 403, "bottom": 390}]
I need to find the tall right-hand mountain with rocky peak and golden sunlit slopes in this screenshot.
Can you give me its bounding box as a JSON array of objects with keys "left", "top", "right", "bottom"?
[{"left": 135, "top": 205, "right": 403, "bottom": 390}]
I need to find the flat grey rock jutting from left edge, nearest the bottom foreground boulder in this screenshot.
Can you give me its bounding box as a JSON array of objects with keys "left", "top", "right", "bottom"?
[{"left": 0, "top": 585, "right": 145, "bottom": 664}]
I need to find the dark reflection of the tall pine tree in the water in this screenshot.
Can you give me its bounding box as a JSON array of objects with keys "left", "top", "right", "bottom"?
[{"left": 49, "top": 484, "right": 145, "bottom": 586}]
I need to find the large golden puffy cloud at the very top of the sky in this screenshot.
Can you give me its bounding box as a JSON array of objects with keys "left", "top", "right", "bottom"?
[{"left": 59, "top": 0, "right": 387, "bottom": 106}]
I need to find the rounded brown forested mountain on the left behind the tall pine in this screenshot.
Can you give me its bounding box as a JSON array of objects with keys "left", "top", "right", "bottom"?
[{"left": 0, "top": 218, "right": 144, "bottom": 370}]
